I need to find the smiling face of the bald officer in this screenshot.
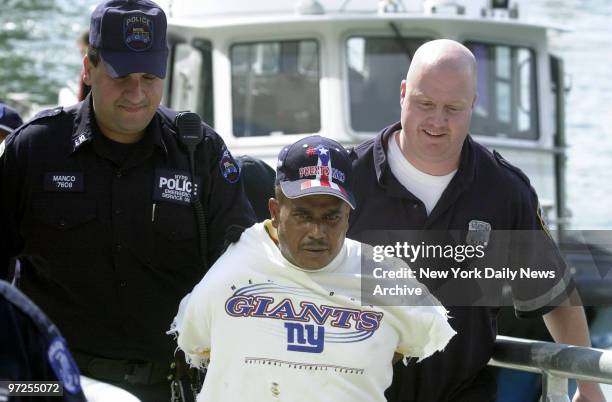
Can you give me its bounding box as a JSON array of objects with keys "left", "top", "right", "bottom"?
[{"left": 400, "top": 66, "right": 476, "bottom": 174}]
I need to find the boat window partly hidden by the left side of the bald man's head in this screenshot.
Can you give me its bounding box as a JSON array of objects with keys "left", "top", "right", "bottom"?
[{"left": 346, "top": 36, "right": 430, "bottom": 132}]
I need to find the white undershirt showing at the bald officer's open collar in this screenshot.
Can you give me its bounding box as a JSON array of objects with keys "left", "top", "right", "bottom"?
[{"left": 387, "top": 135, "right": 457, "bottom": 215}]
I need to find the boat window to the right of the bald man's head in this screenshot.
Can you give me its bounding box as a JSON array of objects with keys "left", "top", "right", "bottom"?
[{"left": 466, "top": 42, "right": 538, "bottom": 140}]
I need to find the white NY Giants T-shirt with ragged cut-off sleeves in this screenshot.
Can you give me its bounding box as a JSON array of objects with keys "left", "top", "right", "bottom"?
[{"left": 170, "top": 221, "right": 455, "bottom": 402}]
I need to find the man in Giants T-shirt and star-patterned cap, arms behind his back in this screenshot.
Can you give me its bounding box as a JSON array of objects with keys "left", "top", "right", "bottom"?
[{"left": 170, "top": 136, "right": 454, "bottom": 402}]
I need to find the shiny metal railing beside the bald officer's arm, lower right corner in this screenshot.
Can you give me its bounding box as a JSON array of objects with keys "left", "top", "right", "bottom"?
[{"left": 489, "top": 335, "right": 612, "bottom": 402}]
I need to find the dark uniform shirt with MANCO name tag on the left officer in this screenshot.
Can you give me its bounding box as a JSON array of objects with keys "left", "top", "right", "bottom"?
[{"left": 0, "top": 97, "right": 255, "bottom": 362}]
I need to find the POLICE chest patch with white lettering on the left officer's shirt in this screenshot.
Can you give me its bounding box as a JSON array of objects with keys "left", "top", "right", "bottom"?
[{"left": 153, "top": 169, "right": 200, "bottom": 205}]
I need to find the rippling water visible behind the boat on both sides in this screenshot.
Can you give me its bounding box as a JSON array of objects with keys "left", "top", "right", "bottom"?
[{"left": 0, "top": 0, "right": 612, "bottom": 229}]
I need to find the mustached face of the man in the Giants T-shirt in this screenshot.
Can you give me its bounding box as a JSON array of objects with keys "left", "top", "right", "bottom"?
[{"left": 268, "top": 195, "right": 350, "bottom": 270}]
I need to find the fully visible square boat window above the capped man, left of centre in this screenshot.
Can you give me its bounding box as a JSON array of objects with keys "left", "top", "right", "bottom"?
[{"left": 230, "top": 40, "right": 321, "bottom": 137}]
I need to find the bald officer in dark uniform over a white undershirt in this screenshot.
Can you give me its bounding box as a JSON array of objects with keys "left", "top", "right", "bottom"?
[{"left": 348, "top": 40, "right": 604, "bottom": 402}]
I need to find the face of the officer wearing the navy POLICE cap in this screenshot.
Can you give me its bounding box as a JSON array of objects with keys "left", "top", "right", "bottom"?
[{"left": 84, "top": 57, "right": 163, "bottom": 143}]
